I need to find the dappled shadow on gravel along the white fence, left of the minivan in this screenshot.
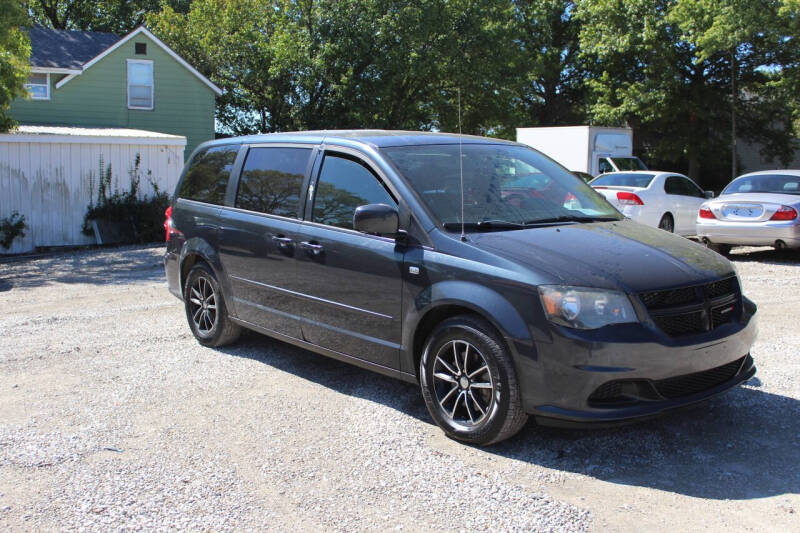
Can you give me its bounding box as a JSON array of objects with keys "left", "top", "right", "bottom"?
[{"left": 0, "top": 246, "right": 164, "bottom": 291}]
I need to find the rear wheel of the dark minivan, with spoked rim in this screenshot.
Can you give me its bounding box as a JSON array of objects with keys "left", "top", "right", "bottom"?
[{"left": 183, "top": 263, "right": 242, "bottom": 347}]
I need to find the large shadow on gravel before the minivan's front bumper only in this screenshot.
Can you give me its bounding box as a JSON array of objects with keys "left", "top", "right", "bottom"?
[{"left": 491, "top": 379, "right": 800, "bottom": 500}]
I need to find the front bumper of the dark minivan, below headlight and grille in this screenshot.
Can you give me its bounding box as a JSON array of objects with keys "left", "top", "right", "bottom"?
[{"left": 518, "top": 299, "right": 757, "bottom": 426}]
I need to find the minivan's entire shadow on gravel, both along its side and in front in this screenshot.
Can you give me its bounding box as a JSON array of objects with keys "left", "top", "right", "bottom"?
[{"left": 219, "top": 332, "right": 800, "bottom": 500}]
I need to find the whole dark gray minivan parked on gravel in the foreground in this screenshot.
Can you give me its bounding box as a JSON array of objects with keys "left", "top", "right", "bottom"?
[{"left": 164, "top": 130, "right": 756, "bottom": 444}]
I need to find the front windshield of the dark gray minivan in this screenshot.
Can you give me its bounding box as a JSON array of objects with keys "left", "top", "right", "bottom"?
[{"left": 384, "top": 144, "right": 622, "bottom": 231}]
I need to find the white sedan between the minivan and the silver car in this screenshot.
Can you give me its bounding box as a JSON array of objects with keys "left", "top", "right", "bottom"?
[{"left": 589, "top": 170, "right": 714, "bottom": 235}]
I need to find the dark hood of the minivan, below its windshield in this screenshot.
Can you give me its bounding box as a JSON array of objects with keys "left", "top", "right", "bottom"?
[{"left": 469, "top": 220, "right": 733, "bottom": 293}]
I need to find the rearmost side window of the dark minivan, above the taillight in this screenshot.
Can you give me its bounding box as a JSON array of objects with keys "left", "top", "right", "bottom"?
[{"left": 178, "top": 144, "right": 239, "bottom": 205}]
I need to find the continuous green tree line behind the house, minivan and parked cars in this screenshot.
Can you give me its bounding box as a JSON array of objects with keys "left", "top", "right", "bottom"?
[{"left": 15, "top": 0, "right": 800, "bottom": 187}]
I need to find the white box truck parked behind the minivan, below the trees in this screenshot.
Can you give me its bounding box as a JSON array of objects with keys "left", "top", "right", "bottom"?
[{"left": 517, "top": 126, "right": 647, "bottom": 176}]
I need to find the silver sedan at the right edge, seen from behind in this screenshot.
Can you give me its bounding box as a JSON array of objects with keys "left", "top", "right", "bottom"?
[{"left": 697, "top": 170, "right": 800, "bottom": 253}]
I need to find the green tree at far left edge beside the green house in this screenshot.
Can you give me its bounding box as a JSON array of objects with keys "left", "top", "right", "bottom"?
[{"left": 0, "top": 0, "right": 31, "bottom": 132}]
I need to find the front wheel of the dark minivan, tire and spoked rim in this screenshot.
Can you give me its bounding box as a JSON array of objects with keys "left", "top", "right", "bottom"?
[{"left": 420, "top": 315, "right": 528, "bottom": 445}]
